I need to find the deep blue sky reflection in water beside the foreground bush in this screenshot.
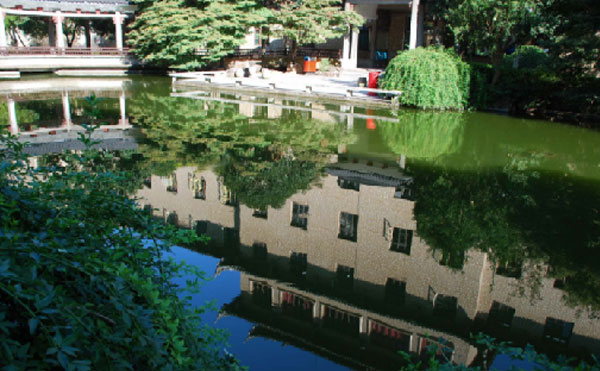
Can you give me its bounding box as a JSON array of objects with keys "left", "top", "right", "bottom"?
[{"left": 173, "top": 247, "right": 347, "bottom": 370}]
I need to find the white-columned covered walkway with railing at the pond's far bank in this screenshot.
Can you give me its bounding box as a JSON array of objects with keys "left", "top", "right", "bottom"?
[{"left": 0, "top": 0, "right": 135, "bottom": 71}]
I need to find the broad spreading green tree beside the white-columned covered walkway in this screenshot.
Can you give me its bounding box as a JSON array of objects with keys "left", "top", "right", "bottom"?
[{"left": 128, "top": 0, "right": 268, "bottom": 70}]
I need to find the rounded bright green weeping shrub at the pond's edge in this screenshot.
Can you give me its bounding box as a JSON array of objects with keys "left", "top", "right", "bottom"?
[{"left": 381, "top": 48, "right": 470, "bottom": 109}]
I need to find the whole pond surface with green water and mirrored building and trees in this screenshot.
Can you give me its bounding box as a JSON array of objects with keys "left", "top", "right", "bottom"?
[{"left": 7, "top": 77, "right": 600, "bottom": 370}]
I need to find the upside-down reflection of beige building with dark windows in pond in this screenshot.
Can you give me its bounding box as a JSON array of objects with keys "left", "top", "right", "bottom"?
[{"left": 138, "top": 159, "right": 600, "bottom": 369}]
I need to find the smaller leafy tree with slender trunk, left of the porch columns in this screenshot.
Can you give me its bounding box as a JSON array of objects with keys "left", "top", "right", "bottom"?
[{"left": 267, "top": 0, "right": 364, "bottom": 67}]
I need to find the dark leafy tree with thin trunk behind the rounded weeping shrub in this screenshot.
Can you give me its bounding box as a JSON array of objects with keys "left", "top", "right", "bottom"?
[{"left": 437, "top": 0, "right": 553, "bottom": 84}]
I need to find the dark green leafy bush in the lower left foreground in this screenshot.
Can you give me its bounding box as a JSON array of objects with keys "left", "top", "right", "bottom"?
[{"left": 0, "top": 105, "right": 237, "bottom": 370}]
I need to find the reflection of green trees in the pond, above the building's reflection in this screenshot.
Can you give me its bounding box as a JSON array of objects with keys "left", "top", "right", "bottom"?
[{"left": 130, "top": 88, "right": 354, "bottom": 209}]
